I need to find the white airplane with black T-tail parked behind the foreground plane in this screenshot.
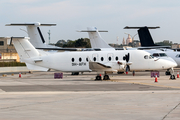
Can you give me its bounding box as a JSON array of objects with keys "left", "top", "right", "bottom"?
[{"left": 124, "top": 26, "right": 180, "bottom": 75}]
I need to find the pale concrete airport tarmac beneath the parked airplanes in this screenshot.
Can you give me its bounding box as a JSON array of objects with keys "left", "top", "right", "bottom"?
[{"left": 0, "top": 70, "right": 180, "bottom": 120}]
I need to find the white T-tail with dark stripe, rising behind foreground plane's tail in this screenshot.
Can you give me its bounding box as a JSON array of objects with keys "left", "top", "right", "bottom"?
[{"left": 6, "top": 22, "right": 56, "bottom": 48}]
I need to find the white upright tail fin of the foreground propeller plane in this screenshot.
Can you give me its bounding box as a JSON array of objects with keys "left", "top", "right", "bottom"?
[{"left": 12, "top": 37, "right": 39, "bottom": 58}]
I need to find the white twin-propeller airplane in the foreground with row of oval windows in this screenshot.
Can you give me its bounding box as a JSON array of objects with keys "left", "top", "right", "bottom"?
[{"left": 12, "top": 37, "right": 177, "bottom": 80}]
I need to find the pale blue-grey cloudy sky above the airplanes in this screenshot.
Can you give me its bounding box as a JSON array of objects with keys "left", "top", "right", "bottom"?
[{"left": 0, "top": 0, "right": 180, "bottom": 44}]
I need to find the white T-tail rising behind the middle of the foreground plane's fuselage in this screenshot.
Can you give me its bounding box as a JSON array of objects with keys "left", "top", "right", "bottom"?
[{"left": 80, "top": 27, "right": 112, "bottom": 48}]
